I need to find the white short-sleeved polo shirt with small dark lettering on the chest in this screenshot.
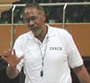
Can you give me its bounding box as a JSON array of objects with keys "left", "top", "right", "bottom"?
[{"left": 14, "top": 26, "right": 83, "bottom": 83}]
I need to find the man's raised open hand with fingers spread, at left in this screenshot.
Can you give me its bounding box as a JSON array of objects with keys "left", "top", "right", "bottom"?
[{"left": 0, "top": 49, "right": 23, "bottom": 67}]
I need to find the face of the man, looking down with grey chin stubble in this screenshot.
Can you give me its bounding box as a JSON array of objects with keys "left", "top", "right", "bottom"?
[{"left": 24, "top": 7, "right": 45, "bottom": 36}]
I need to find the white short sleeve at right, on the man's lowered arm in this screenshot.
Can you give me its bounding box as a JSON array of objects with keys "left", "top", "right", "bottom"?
[{"left": 62, "top": 31, "right": 83, "bottom": 68}]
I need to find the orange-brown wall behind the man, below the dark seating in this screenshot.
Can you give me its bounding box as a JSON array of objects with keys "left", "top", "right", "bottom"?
[{"left": 0, "top": 23, "right": 90, "bottom": 56}]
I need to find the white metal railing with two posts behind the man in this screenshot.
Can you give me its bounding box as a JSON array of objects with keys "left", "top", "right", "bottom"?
[{"left": 0, "top": 2, "right": 90, "bottom": 47}]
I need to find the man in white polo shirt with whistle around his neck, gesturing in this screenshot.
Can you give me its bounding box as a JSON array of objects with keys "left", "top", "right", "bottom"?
[{"left": 2, "top": 4, "right": 90, "bottom": 83}]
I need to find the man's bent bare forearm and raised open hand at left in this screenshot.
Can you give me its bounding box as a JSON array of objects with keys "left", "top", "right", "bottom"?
[{"left": 1, "top": 49, "right": 23, "bottom": 79}]
